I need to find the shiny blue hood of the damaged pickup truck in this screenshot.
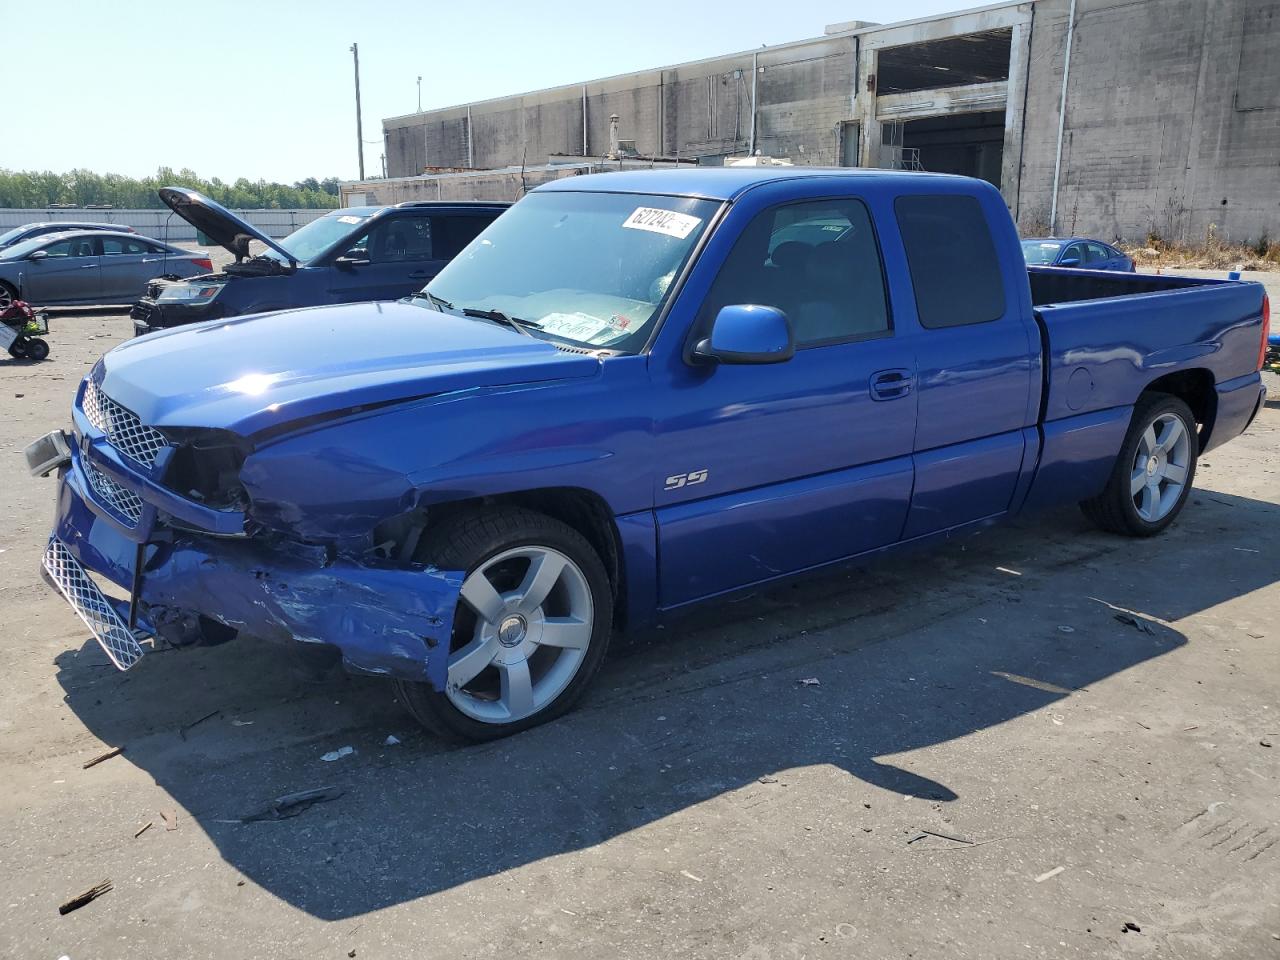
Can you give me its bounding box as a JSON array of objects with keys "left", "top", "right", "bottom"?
[{"left": 92, "top": 301, "right": 600, "bottom": 436}]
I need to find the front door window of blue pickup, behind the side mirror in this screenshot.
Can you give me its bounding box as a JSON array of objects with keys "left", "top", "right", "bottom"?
[{"left": 699, "top": 198, "right": 891, "bottom": 347}]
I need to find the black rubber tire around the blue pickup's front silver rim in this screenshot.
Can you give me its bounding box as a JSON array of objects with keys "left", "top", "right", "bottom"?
[{"left": 396, "top": 507, "right": 613, "bottom": 742}]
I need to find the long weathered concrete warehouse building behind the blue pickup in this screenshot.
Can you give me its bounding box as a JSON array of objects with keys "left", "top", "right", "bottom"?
[{"left": 373, "top": 0, "right": 1280, "bottom": 241}]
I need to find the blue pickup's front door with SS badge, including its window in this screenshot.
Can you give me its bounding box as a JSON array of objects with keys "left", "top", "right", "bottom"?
[{"left": 654, "top": 193, "right": 915, "bottom": 608}]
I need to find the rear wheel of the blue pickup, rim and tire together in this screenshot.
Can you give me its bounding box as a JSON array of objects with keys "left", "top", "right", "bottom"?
[{"left": 1080, "top": 393, "right": 1199, "bottom": 536}]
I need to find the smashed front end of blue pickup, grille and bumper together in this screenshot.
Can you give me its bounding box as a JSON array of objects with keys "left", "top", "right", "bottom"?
[{"left": 28, "top": 375, "right": 462, "bottom": 690}]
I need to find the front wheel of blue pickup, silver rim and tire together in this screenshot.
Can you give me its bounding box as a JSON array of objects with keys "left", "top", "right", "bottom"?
[{"left": 397, "top": 508, "right": 613, "bottom": 740}]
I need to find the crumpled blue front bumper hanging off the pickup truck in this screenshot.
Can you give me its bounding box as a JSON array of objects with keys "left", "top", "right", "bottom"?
[{"left": 45, "top": 447, "right": 462, "bottom": 690}]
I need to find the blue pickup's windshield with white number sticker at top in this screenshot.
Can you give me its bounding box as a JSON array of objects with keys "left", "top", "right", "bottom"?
[{"left": 419, "top": 191, "right": 718, "bottom": 352}]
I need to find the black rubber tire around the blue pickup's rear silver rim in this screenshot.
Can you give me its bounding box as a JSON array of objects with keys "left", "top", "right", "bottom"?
[{"left": 1080, "top": 393, "right": 1199, "bottom": 536}]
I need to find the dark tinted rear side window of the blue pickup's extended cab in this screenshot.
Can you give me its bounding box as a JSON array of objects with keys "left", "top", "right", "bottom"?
[{"left": 893, "top": 197, "right": 1005, "bottom": 329}]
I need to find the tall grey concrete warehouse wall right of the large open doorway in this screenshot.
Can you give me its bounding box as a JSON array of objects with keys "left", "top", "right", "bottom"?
[{"left": 1016, "top": 0, "right": 1280, "bottom": 241}]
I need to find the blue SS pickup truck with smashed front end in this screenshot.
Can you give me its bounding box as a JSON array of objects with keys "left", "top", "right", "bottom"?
[{"left": 28, "top": 168, "right": 1268, "bottom": 740}]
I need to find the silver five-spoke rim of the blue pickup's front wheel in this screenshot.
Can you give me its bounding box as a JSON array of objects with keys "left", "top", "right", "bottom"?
[{"left": 445, "top": 547, "right": 595, "bottom": 723}]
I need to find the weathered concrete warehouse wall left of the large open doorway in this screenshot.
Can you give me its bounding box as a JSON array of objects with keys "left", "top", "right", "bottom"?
[{"left": 383, "top": 36, "right": 856, "bottom": 177}]
